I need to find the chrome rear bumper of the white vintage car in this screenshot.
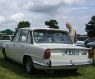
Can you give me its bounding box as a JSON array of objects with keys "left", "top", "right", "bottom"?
[{"left": 34, "top": 60, "right": 92, "bottom": 70}]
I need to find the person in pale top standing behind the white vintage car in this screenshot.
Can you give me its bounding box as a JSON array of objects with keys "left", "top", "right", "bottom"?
[{"left": 66, "top": 22, "right": 77, "bottom": 43}]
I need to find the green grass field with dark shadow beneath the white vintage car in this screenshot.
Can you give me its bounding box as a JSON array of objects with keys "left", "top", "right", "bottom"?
[{"left": 0, "top": 51, "right": 95, "bottom": 79}]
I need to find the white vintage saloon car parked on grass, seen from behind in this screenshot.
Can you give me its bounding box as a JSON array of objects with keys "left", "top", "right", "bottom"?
[{"left": 2, "top": 28, "right": 93, "bottom": 72}]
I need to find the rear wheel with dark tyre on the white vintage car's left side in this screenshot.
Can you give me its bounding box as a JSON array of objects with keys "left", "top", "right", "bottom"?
[{"left": 25, "top": 57, "right": 35, "bottom": 73}]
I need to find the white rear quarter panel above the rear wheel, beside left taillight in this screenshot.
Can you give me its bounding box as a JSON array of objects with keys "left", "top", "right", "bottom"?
[{"left": 20, "top": 44, "right": 45, "bottom": 63}]
